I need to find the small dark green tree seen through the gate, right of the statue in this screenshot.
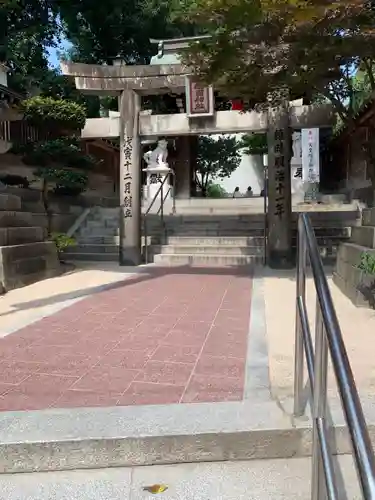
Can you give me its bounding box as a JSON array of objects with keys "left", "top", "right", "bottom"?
[{"left": 195, "top": 135, "right": 241, "bottom": 196}]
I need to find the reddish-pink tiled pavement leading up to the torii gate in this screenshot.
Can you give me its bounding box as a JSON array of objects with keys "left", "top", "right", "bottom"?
[{"left": 0, "top": 268, "right": 251, "bottom": 411}]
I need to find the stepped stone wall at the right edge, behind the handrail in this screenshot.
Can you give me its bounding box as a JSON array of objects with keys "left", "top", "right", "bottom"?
[{"left": 333, "top": 208, "right": 375, "bottom": 307}]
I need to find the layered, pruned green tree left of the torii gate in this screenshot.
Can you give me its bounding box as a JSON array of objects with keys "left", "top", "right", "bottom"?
[{"left": 13, "top": 97, "right": 95, "bottom": 235}]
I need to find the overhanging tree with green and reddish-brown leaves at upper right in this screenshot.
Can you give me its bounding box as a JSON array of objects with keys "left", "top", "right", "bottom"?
[{"left": 177, "top": 0, "right": 375, "bottom": 185}]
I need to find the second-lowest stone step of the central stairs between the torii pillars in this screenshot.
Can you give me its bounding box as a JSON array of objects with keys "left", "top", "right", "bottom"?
[{"left": 160, "top": 244, "right": 263, "bottom": 256}]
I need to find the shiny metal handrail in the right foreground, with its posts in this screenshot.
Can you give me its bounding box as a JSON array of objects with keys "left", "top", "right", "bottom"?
[{"left": 294, "top": 214, "right": 375, "bottom": 500}]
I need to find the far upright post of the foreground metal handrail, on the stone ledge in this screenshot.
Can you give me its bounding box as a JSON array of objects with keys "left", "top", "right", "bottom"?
[{"left": 294, "top": 219, "right": 307, "bottom": 417}]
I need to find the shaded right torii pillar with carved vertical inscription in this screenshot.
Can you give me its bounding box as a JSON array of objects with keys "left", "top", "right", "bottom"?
[{"left": 267, "top": 104, "right": 294, "bottom": 269}]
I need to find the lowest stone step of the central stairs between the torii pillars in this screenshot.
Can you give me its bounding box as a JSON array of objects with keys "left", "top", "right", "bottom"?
[{"left": 154, "top": 253, "right": 263, "bottom": 266}]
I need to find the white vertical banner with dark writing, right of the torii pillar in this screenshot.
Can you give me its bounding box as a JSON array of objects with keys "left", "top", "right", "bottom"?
[{"left": 302, "top": 128, "right": 320, "bottom": 183}]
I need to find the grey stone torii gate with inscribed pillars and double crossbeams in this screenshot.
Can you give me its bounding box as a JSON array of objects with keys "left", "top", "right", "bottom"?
[{"left": 61, "top": 39, "right": 333, "bottom": 268}]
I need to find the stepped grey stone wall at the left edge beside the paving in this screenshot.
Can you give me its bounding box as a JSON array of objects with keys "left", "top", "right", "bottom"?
[{"left": 0, "top": 193, "right": 60, "bottom": 292}]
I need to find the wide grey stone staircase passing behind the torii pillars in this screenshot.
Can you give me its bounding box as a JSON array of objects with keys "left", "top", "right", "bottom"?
[{"left": 65, "top": 207, "right": 358, "bottom": 266}]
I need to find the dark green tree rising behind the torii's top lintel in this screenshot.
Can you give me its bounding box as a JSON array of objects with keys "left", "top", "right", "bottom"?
[{"left": 57, "top": 0, "right": 195, "bottom": 64}]
